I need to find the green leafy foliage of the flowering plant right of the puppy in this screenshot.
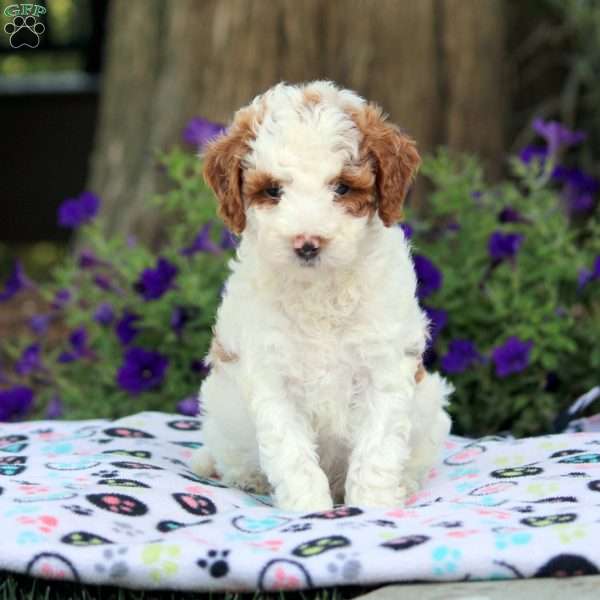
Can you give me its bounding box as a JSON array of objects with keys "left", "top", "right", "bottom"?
[{"left": 408, "top": 151, "right": 600, "bottom": 435}]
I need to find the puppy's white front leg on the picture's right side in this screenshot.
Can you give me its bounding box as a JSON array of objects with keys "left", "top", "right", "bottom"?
[{"left": 346, "top": 358, "right": 417, "bottom": 507}]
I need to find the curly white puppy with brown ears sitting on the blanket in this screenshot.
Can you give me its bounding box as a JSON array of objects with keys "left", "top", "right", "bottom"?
[{"left": 193, "top": 81, "right": 452, "bottom": 511}]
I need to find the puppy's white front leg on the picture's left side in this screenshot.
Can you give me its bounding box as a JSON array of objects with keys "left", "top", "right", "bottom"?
[{"left": 250, "top": 369, "right": 333, "bottom": 511}]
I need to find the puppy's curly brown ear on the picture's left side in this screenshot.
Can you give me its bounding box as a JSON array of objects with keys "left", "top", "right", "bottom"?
[{"left": 203, "top": 108, "right": 254, "bottom": 235}]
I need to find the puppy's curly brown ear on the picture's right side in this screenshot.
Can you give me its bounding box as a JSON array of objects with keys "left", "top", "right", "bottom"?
[{"left": 353, "top": 104, "right": 421, "bottom": 227}]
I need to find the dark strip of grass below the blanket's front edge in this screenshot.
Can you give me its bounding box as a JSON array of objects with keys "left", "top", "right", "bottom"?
[{"left": 0, "top": 571, "right": 370, "bottom": 600}]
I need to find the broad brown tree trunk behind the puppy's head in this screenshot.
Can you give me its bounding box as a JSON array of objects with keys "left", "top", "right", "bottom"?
[{"left": 90, "top": 0, "right": 505, "bottom": 241}]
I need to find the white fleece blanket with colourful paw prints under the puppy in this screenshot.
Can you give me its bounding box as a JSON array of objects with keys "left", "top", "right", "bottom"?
[{"left": 0, "top": 412, "right": 600, "bottom": 590}]
